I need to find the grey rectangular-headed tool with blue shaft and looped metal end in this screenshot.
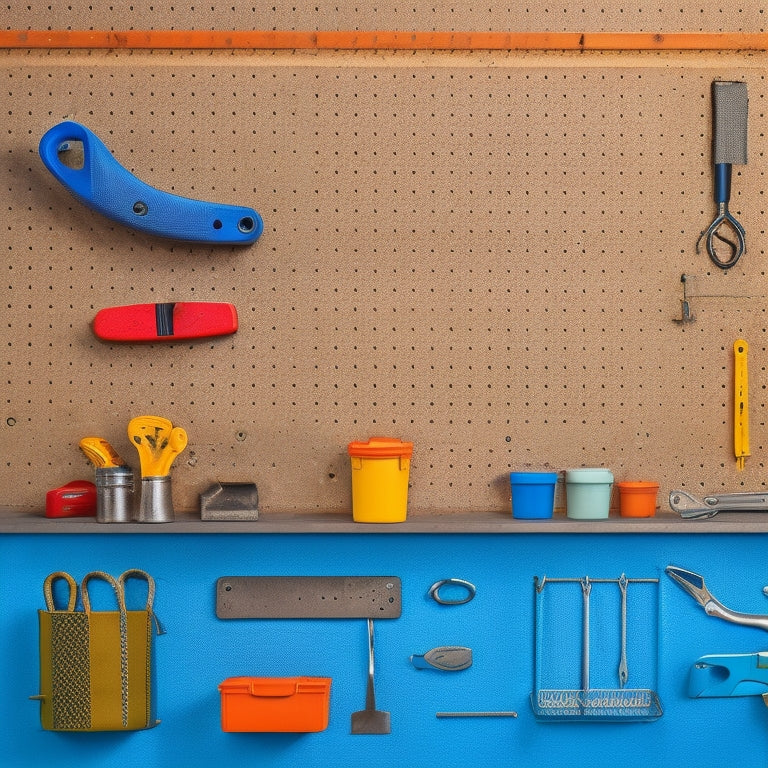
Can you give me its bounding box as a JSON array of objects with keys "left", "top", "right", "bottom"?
[{"left": 696, "top": 81, "right": 749, "bottom": 269}]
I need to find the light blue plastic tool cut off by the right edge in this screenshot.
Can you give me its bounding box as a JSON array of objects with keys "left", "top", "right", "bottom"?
[{"left": 688, "top": 652, "right": 768, "bottom": 699}]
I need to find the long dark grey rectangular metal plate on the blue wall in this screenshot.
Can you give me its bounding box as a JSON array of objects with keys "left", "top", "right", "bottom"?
[{"left": 216, "top": 576, "right": 402, "bottom": 619}]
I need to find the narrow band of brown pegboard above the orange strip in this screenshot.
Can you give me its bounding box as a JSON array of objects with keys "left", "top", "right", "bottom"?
[{"left": 5, "top": 0, "right": 765, "bottom": 32}]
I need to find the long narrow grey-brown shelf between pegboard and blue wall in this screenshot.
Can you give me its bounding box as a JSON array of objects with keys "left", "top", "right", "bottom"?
[{"left": 0, "top": 507, "right": 768, "bottom": 534}]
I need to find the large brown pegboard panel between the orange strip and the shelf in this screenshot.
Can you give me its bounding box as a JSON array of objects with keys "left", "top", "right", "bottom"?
[{"left": 0, "top": 48, "right": 768, "bottom": 513}]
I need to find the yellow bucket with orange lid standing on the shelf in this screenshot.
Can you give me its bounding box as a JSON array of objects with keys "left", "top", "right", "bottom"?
[{"left": 347, "top": 437, "right": 413, "bottom": 523}]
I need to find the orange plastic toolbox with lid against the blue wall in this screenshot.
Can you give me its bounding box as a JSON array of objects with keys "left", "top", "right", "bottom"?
[{"left": 219, "top": 677, "right": 331, "bottom": 733}]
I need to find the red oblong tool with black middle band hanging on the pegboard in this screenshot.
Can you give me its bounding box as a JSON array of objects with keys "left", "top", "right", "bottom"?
[{"left": 93, "top": 301, "right": 237, "bottom": 341}]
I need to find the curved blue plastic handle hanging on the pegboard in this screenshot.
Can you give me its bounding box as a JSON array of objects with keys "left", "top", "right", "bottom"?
[{"left": 39, "top": 121, "right": 264, "bottom": 245}]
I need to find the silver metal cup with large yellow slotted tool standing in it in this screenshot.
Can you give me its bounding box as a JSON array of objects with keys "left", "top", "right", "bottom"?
[{"left": 128, "top": 416, "right": 187, "bottom": 523}]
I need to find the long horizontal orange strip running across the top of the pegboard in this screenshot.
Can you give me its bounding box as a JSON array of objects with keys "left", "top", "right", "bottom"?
[{"left": 0, "top": 29, "right": 768, "bottom": 51}]
